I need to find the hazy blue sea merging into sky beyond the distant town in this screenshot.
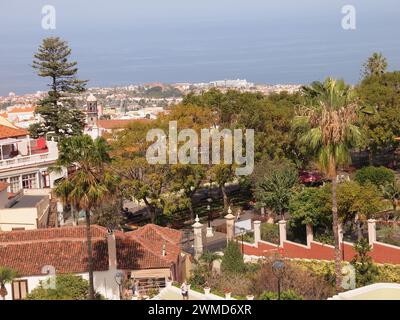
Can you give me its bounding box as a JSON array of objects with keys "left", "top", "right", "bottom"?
[{"left": 0, "top": 0, "right": 400, "bottom": 95}]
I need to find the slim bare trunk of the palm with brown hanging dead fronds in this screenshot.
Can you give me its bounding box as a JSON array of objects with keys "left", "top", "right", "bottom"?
[{"left": 332, "top": 172, "right": 342, "bottom": 292}]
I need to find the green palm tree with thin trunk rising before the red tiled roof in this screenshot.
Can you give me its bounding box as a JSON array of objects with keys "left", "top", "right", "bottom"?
[{"left": 55, "top": 135, "right": 116, "bottom": 300}]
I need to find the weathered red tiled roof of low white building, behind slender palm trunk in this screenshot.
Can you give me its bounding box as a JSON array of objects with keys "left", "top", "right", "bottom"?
[{"left": 0, "top": 225, "right": 180, "bottom": 276}]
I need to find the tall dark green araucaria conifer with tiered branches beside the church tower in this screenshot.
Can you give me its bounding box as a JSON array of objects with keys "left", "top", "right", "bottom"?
[{"left": 29, "top": 37, "right": 87, "bottom": 137}]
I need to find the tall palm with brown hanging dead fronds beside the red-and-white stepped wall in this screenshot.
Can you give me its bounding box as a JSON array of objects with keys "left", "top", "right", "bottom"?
[{"left": 294, "top": 78, "right": 362, "bottom": 291}]
